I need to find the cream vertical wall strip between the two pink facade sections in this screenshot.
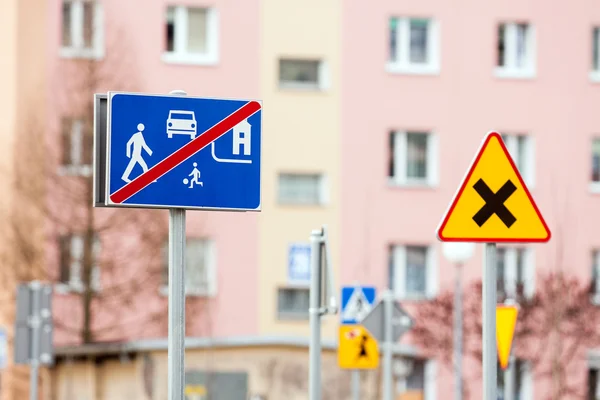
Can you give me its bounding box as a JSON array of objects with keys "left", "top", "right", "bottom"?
[{"left": 259, "top": 0, "right": 342, "bottom": 338}]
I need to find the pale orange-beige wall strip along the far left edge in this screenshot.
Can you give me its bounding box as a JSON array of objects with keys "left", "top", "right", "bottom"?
[{"left": 0, "top": 0, "right": 48, "bottom": 400}]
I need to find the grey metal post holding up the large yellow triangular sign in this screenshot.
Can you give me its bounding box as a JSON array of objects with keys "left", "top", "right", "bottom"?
[{"left": 482, "top": 243, "right": 497, "bottom": 400}]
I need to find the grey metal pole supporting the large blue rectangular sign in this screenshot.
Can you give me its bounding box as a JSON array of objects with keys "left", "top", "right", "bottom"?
[{"left": 167, "top": 90, "right": 187, "bottom": 400}]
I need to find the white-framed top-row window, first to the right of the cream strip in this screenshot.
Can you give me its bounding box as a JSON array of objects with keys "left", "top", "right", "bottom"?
[{"left": 387, "top": 17, "right": 439, "bottom": 74}]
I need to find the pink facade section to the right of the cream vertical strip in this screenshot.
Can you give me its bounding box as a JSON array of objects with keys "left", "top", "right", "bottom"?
[{"left": 341, "top": 0, "right": 600, "bottom": 399}]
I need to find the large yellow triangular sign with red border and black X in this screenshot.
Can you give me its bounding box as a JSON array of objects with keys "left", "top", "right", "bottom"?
[{"left": 437, "top": 132, "right": 550, "bottom": 242}]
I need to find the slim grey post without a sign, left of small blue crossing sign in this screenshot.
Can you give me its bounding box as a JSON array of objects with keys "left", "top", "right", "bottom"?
[{"left": 308, "top": 230, "right": 322, "bottom": 400}]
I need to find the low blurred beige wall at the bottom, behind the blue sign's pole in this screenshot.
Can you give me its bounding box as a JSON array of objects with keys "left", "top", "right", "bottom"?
[{"left": 53, "top": 347, "right": 379, "bottom": 400}]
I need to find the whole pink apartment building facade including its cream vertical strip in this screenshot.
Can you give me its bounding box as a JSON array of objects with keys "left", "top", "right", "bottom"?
[{"left": 21, "top": 0, "right": 600, "bottom": 400}]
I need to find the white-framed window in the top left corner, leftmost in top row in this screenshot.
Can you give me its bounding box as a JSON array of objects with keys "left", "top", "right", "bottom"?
[{"left": 61, "top": 0, "right": 104, "bottom": 58}]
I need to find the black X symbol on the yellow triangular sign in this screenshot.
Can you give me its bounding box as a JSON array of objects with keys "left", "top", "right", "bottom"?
[{"left": 473, "top": 179, "right": 517, "bottom": 228}]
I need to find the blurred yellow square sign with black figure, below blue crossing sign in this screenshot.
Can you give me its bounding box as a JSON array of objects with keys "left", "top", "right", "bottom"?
[{"left": 338, "top": 325, "right": 379, "bottom": 369}]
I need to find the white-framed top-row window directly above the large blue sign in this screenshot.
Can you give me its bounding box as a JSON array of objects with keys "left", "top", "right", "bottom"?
[{"left": 163, "top": 6, "right": 219, "bottom": 65}]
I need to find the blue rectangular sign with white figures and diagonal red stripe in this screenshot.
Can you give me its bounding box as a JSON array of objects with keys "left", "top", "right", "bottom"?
[{"left": 106, "top": 92, "right": 262, "bottom": 211}]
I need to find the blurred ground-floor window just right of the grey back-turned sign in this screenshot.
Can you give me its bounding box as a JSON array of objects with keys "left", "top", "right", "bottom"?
[{"left": 393, "top": 357, "right": 437, "bottom": 400}]
